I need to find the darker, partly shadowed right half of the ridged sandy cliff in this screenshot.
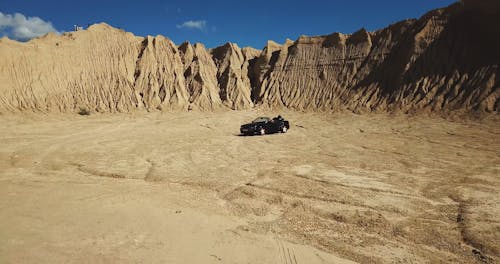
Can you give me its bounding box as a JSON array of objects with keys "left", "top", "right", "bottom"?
[{"left": 257, "top": 1, "right": 500, "bottom": 112}]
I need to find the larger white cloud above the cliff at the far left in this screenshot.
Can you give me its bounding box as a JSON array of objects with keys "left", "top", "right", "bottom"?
[{"left": 0, "top": 12, "right": 58, "bottom": 40}]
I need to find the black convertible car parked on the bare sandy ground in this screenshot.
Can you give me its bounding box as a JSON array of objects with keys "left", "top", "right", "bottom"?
[{"left": 240, "top": 116, "right": 290, "bottom": 136}]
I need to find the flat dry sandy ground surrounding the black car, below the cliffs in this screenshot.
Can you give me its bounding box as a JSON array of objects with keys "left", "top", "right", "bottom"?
[{"left": 0, "top": 110, "right": 500, "bottom": 264}]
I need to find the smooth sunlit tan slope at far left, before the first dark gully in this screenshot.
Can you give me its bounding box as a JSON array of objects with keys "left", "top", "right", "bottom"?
[{"left": 0, "top": 25, "right": 141, "bottom": 112}]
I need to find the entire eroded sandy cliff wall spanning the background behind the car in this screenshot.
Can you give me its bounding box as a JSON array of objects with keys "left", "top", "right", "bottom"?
[{"left": 0, "top": 0, "right": 500, "bottom": 113}]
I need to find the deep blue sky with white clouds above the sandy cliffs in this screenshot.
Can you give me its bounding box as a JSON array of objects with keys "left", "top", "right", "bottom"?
[{"left": 0, "top": 0, "right": 455, "bottom": 49}]
